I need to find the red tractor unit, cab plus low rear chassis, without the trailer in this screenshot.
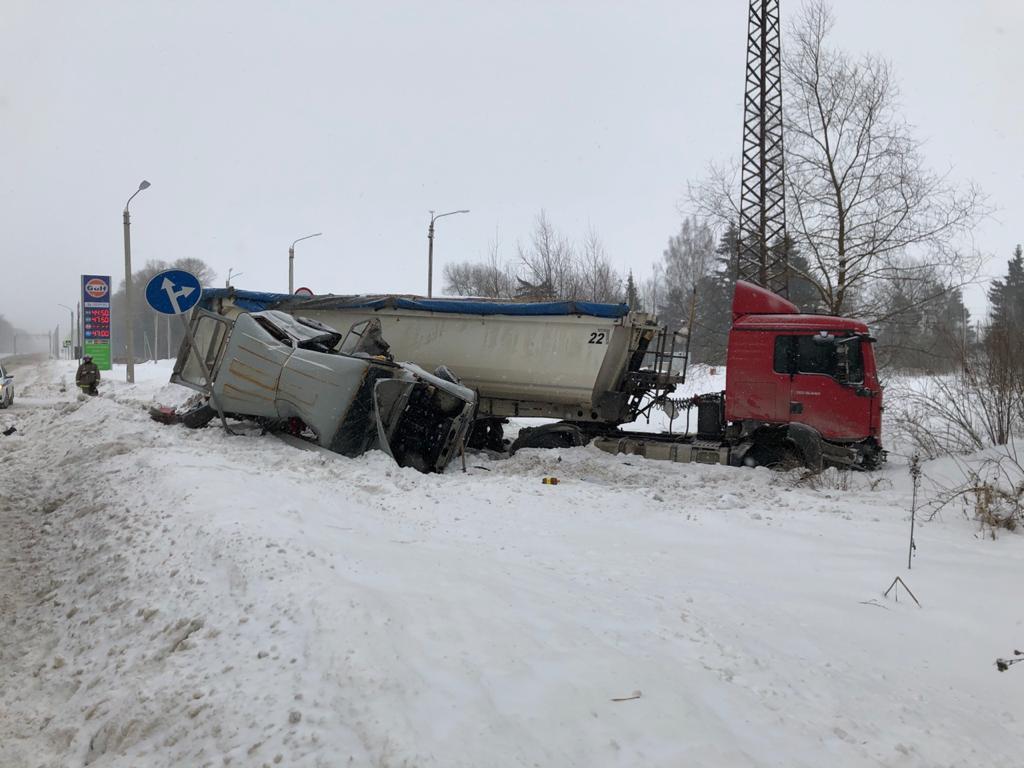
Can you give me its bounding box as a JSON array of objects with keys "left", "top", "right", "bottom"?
[{"left": 595, "top": 281, "right": 886, "bottom": 469}]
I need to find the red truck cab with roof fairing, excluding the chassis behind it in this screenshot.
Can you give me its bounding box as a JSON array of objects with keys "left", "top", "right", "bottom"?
[{"left": 725, "top": 281, "right": 885, "bottom": 467}]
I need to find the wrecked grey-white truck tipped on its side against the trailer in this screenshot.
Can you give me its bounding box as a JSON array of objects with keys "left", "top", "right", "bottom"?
[{"left": 163, "top": 310, "right": 476, "bottom": 472}]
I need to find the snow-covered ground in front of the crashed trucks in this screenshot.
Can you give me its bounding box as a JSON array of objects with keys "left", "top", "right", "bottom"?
[{"left": 0, "top": 361, "right": 1024, "bottom": 768}]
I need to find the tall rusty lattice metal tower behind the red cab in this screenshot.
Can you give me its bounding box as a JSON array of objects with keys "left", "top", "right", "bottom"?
[{"left": 736, "top": 0, "right": 788, "bottom": 296}]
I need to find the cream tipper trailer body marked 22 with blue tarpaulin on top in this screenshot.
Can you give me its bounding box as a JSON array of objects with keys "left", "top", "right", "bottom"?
[{"left": 204, "top": 289, "right": 685, "bottom": 424}]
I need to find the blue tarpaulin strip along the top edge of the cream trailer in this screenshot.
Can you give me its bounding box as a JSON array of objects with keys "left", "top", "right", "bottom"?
[{"left": 202, "top": 288, "right": 630, "bottom": 318}]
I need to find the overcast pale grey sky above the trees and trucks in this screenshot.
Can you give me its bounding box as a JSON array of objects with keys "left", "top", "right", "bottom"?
[{"left": 0, "top": 0, "right": 1024, "bottom": 331}]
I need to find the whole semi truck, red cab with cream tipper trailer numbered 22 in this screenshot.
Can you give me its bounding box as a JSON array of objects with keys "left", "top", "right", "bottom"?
[{"left": 197, "top": 281, "right": 885, "bottom": 469}]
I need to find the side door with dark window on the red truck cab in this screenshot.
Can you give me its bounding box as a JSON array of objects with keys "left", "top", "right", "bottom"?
[{"left": 774, "top": 334, "right": 873, "bottom": 440}]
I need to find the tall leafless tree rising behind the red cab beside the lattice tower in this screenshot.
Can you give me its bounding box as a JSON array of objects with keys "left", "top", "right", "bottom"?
[{"left": 688, "top": 0, "right": 989, "bottom": 318}]
